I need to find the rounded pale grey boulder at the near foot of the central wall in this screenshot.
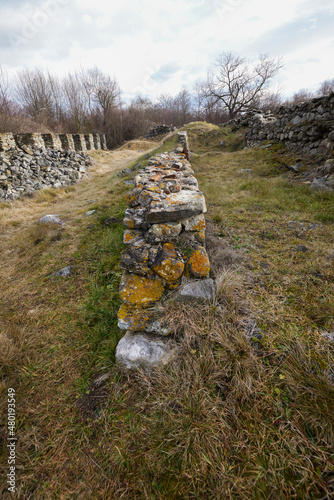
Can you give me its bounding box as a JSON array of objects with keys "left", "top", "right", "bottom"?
[{"left": 116, "top": 332, "right": 176, "bottom": 369}]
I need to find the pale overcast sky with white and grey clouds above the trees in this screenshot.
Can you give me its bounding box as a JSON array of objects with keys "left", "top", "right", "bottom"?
[{"left": 0, "top": 0, "right": 334, "bottom": 101}]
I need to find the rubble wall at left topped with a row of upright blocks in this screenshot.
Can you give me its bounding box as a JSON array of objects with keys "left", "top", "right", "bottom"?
[{"left": 0, "top": 134, "right": 107, "bottom": 201}]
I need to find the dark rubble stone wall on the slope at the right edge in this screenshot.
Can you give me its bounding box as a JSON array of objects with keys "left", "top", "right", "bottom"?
[{"left": 229, "top": 93, "right": 334, "bottom": 158}]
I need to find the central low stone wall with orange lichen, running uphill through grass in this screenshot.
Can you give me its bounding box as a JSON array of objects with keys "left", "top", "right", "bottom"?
[{"left": 116, "top": 133, "right": 213, "bottom": 368}]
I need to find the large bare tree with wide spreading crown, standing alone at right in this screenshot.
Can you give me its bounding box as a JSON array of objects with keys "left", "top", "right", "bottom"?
[{"left": 206, "top": 52, "right": 282, "bottom": 118}]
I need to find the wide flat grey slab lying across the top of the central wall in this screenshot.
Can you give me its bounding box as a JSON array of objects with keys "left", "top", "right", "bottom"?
[{"left": 146, "top": 191, "right": 206, "bottom": 223}]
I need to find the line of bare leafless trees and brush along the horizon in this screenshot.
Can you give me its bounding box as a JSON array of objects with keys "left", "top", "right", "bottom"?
[{"left": 0, "top": 52, "right": 334, "bottom": 147}]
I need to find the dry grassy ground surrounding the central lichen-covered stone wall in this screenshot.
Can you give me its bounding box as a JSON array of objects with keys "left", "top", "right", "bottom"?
[{"left": 0, "top": 127, "right": 334, "bottom": 500}]
